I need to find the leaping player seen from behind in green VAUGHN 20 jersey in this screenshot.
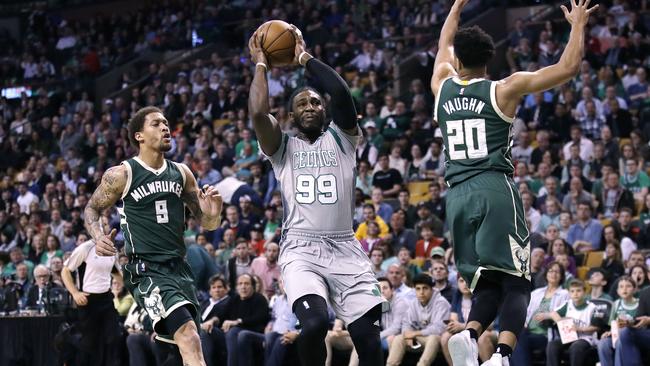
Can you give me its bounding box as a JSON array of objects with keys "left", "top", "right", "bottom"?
[{"left": 431, "top": 0, "right": 597, "bottom": 366}]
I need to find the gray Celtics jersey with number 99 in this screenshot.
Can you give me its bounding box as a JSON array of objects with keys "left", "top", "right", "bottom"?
[{"left": 260, "top": 123, "right": 361, "bottom": 234}]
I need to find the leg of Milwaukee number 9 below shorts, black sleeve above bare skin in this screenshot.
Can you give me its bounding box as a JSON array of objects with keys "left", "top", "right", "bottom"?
[{"left": 165, "top": 306, "right": 205, "bottom": 366}]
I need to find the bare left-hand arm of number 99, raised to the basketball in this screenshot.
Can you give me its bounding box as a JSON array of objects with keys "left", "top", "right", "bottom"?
[{"left": 248, "top": 32, "right": 282, "bottom": 155}]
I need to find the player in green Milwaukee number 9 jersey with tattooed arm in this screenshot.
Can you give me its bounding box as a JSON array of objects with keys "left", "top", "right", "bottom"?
[{"left": 84, "top": 107, "right": 223, "bottom": 366}]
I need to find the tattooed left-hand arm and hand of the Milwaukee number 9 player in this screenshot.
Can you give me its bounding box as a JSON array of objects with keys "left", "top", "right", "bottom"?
[{"left": 84, "top": 165, "right": 127, "bottom": 256}]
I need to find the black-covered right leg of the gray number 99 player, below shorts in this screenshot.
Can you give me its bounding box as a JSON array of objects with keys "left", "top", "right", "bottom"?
[{"left": 348, "top": 304, "right": 384, "bottom": 366}]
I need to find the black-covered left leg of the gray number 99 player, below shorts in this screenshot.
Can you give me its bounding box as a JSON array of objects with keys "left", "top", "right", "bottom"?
[{"left": 292, "top": 294, "right": 329, "bottom": 366}]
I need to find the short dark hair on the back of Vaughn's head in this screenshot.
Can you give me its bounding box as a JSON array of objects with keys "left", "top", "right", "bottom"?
[{"left": 454, "top": 26, "right": 494, "bottom": 68}]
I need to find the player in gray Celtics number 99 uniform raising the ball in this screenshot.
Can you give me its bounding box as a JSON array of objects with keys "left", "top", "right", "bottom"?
[{"left": 249, "top": 27, "right": 386, "bottom": 365}]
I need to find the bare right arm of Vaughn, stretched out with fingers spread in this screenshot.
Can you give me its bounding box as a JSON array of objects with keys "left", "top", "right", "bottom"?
[{"left": 497, "top": 0, "right": 598, "bottom": 116}]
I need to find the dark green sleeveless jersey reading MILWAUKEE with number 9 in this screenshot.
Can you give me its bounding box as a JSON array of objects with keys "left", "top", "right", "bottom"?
[{"left": 118, "top": 157, "right": 185, "bottom": 262}]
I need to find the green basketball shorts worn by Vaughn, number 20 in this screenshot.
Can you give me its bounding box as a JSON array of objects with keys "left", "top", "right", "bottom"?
[{"left": 446, "top": 172, "right": 530, "bottom": 290}]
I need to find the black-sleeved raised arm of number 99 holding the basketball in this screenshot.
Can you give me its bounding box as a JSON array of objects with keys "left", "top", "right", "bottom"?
[{"left": 292, "top": 25, "right": 359, "bottom": 136}]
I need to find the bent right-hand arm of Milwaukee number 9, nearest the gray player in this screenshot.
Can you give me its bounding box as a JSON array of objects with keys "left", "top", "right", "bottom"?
[{"left": 180, "top": 164, "right": 223, "bottom": 230}]
